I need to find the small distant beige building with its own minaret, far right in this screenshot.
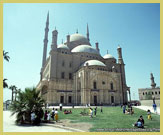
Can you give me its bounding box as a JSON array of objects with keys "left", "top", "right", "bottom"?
[{"left": 138, "top": 73, "right": 160, "bottom": 106}]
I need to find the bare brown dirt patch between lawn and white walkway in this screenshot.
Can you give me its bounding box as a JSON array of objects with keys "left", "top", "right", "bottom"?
[{"left": 56, "top": 120, "right": 92, "bottom": 132}]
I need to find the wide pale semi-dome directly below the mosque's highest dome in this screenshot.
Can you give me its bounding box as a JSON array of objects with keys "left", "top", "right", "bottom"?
[{"left": 71, "top": 45, "right": 99, "bottom": 55}]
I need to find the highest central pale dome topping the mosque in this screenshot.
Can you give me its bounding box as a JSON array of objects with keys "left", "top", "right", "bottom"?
[{"left": 70, "top": 33, "right": 90, "bottom": 45}]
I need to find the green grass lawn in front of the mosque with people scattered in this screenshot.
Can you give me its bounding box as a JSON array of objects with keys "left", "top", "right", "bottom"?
[{"left": 47, "top": 107, "right": 160, "bottom": 132}]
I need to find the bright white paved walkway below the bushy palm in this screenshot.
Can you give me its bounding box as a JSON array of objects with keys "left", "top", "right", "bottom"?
[{"left": 3, "top": 111, "right": 73, "bottom": 132}]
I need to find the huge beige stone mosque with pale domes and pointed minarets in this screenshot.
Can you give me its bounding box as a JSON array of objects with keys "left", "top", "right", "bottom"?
[{"left": 37, "top": 13, "right": 131, "bottom": 105}]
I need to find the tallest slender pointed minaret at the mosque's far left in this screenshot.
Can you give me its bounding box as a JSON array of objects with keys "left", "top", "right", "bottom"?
[{"left": 42, "top": 12, "right": 49, "bottom": 68}]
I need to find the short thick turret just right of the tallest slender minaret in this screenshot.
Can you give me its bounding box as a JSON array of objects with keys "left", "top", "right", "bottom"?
[{"left": 51, "top": 28, "right": 58, "bottom": 51}]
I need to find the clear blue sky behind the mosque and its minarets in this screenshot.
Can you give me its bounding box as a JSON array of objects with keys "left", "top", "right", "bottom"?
[{"left": 3, "top": 3, "right": 160, "bottom": 101}]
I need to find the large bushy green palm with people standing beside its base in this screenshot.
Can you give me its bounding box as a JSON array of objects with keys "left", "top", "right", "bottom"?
[{"left": 10, "top": 88, "right": 45, "bottom": 124}]
